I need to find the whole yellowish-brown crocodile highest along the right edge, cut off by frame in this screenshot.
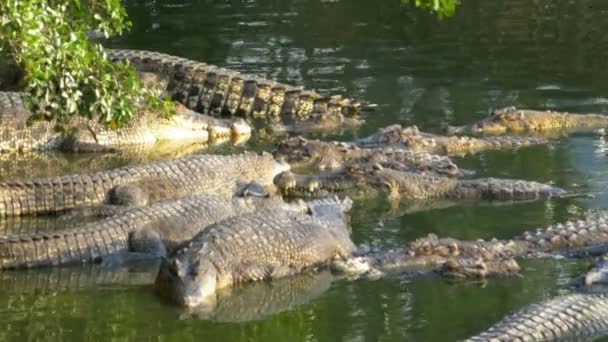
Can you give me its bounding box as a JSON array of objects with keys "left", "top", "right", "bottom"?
[{"left": 447, "top": 107, "right": 608, "bottom": 135}]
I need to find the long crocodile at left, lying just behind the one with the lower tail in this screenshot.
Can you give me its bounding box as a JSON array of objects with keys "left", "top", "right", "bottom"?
[{"left": 0, "top": 152, "right": 290, "bottom": 216}]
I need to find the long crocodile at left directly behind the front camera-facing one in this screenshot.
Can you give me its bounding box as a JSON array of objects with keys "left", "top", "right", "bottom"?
[{"left": 0, "top": 195, "right": 307, "bottom": 269}]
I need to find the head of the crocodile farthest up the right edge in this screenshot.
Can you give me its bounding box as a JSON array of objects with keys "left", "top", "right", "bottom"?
[{"left": 447, "top": 107, "right": 560, "bottom": 135}]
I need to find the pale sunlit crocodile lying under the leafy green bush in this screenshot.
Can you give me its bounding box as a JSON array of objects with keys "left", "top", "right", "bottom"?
[{"left": 0, "top": 92, "right": 251, "bottom": 152}]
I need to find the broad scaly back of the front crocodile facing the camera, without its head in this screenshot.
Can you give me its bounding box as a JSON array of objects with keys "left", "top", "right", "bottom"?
[{"left": 176, "top": 210, "right": 355, "bottom": 288}]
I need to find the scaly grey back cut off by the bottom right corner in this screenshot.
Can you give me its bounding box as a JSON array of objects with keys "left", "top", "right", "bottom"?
[{"left": 466, "top": 293, "right": 608, "bottom": 342}]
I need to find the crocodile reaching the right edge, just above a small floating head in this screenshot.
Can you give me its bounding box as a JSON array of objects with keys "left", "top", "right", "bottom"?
[{"left": 408, "top": 213, "right": 608, "bottom": 260}]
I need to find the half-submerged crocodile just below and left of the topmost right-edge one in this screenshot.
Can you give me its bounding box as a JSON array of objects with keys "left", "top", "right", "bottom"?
[{"left": 353, "top": 125, "right": 548, "bottom": 156}]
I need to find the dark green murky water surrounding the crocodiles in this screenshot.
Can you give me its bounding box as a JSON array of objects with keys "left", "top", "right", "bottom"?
[{"left": 0, "top": 0, "right": 608, "bottom": 341}]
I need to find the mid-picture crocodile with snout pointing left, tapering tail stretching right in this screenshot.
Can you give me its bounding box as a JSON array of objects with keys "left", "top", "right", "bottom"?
[{"left": 275, "top": 164, "right": 569, "bottom": 201}]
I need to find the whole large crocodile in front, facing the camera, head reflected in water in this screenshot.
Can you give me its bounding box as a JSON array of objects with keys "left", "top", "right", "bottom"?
[{"left": 155, "top": 200, "right": 356, "bottom": 307}]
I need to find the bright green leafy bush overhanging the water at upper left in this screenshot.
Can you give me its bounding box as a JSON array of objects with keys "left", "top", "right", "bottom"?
[{"left": 0, "top": 0, "right": 171, "bottom": 126}]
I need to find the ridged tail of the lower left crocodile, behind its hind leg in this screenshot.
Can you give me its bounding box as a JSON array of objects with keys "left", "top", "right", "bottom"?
[{"left": 0, "top": 228, "right": 128, "bottom": 269}]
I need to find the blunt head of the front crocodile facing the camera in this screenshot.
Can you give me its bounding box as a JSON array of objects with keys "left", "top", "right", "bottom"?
[{"left": 154, "top": 251, "right": 217, "bottom": 307}]
